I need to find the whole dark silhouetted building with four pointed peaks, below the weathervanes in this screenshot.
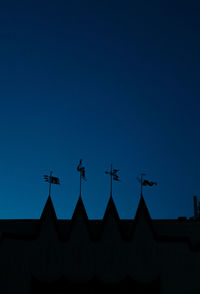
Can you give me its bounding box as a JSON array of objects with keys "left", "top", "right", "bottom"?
[{"left": 0, "top": 196, "right": 200, "bottom": 294}]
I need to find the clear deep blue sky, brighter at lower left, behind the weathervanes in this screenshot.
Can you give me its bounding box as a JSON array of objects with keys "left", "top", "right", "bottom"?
[{"left": 0, "top": 0, "right": 200, "bottom": 219}]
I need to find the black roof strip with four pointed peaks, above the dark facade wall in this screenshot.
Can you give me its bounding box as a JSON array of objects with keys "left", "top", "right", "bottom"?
[{"left": 0, "top": 195, "right": 200, "bottom": 250}]
